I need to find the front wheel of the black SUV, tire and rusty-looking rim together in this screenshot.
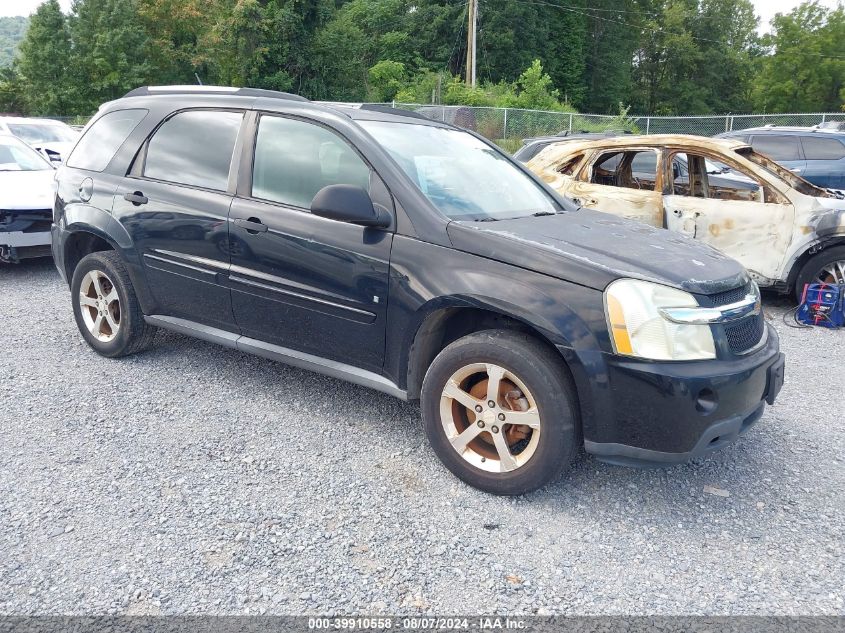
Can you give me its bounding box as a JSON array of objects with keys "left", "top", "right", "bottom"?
[{"left": 421, "top": 330, "right": 580, "bottom": 495}]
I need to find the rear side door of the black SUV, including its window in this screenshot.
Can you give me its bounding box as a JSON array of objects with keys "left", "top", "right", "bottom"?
[{"left": 113, "top": 109, "right": 244, "bottom": 331}]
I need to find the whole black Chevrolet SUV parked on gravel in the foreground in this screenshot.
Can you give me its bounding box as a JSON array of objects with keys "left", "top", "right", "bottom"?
[{"left": 53, "top": 87, "right": 783, "bottom": 494}]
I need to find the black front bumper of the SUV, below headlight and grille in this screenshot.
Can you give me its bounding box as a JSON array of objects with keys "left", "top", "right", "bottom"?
[{"left": 584, "top": 325, "right": 784, "bottom": 466}]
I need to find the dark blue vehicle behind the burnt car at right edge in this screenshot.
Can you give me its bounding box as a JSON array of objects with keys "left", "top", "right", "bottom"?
[{"left": 718, "top": 126, "right": 845, "bottom": 190}]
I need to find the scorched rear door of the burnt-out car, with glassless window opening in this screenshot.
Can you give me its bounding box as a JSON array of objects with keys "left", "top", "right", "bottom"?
[{"left": 566, "top": 149, "right": 663, "bottom": 227}]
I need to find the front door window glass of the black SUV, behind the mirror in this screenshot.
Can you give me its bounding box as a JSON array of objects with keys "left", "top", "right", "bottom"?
[{"left": 252, "top": 116, "right": 370, "bottom": 209}]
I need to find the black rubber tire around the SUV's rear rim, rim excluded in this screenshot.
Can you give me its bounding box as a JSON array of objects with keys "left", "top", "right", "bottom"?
[{"left": 70, "top": 251, "right": 155, "bottom": 358}]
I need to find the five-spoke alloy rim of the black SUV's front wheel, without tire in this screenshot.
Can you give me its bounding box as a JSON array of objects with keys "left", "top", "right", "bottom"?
[{"left": 440, "top": 363, "right": 541, "bottom": 473}]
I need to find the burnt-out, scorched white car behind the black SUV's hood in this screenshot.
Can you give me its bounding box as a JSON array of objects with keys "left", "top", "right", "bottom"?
[{"left": 528, "top": 134, "right": 845, "bottom": 296}]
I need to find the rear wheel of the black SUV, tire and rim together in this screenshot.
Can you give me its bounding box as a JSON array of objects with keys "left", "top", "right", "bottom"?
[{"left": 71, "top": 251, "right": 155, "bottom": 358}]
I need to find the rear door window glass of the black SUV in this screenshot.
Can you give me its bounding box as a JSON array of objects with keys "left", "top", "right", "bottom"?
[{"left": 144, "top": 110, "right": 243, "bottom": 191}]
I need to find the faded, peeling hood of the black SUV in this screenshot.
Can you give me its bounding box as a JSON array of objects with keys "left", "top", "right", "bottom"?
[{"left": 447, "top": 209, "right": 749, "bottom": 294}]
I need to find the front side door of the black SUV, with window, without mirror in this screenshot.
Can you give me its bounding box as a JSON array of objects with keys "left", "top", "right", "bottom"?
[{"left": 229, "top": 114, "right": 393, "bottom": 371}]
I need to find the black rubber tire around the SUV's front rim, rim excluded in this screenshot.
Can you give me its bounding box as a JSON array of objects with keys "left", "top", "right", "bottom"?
[{"left": 420, "top": 330, "right": 581, "bottom": 495}]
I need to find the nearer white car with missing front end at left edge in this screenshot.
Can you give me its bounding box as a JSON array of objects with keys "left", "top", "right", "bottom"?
[{"left": 0, "top": 135, "right": 56, "bottom": 264}]
